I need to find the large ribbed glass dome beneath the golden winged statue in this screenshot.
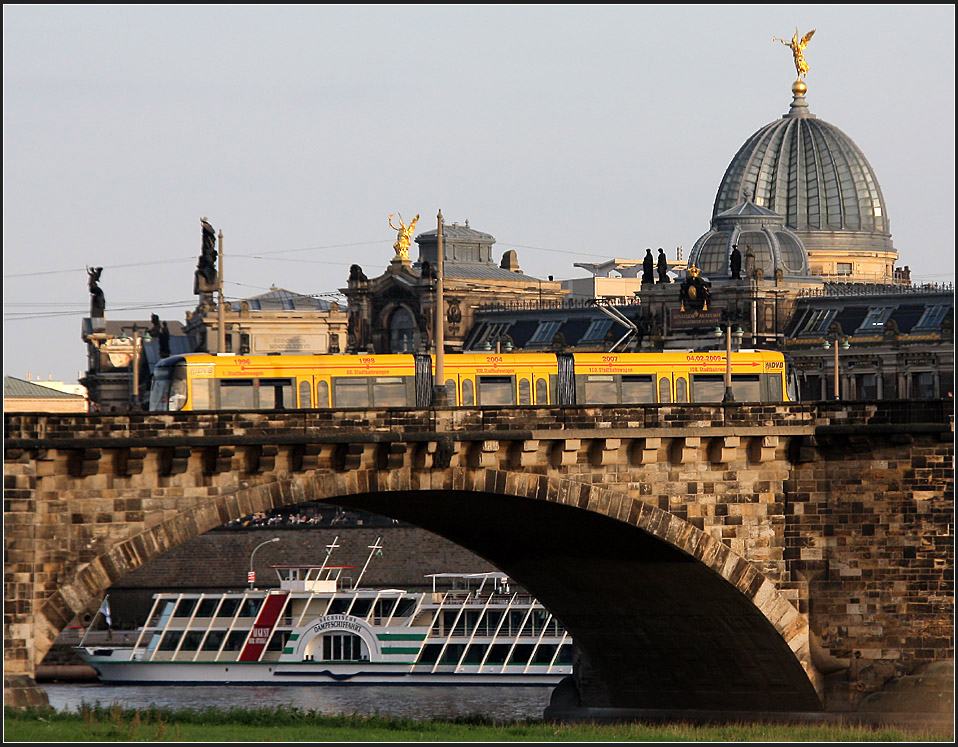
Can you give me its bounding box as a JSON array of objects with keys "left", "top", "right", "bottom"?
[{"left": 712, "top": 82, "right": 895, "bottom": 252}]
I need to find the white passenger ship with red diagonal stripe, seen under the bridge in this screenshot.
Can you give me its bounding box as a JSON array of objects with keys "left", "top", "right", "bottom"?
[{"left": 77, "top": 541, "right": 572, "bottom": 685}]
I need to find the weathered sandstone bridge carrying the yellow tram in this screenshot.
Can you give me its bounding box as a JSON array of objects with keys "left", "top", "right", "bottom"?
[{"left": 4, "top": 402, "right": 954, "bottom": 712}]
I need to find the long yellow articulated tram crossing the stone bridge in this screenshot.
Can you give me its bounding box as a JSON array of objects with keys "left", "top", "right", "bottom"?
[{"left": 150, "top": 350, "right": 797, "bottom": 412}]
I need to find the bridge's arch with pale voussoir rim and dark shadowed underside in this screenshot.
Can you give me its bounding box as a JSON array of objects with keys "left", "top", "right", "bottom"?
[{"left": 45, "top": 466, "right": 823, "bottom": 710}]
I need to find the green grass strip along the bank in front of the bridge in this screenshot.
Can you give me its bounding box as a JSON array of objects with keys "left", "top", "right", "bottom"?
[{"left": 4, "top": 704, "right": 952, "bottom": 743}]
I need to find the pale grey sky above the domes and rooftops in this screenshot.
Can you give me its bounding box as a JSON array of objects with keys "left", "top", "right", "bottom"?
[{"left": 3, "top": 4, "right": 955, "bottom": 383}]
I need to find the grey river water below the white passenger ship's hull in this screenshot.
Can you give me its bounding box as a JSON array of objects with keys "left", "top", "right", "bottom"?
[{"left": 41, "top": 683, "right": 552, "bottom": 721}]
